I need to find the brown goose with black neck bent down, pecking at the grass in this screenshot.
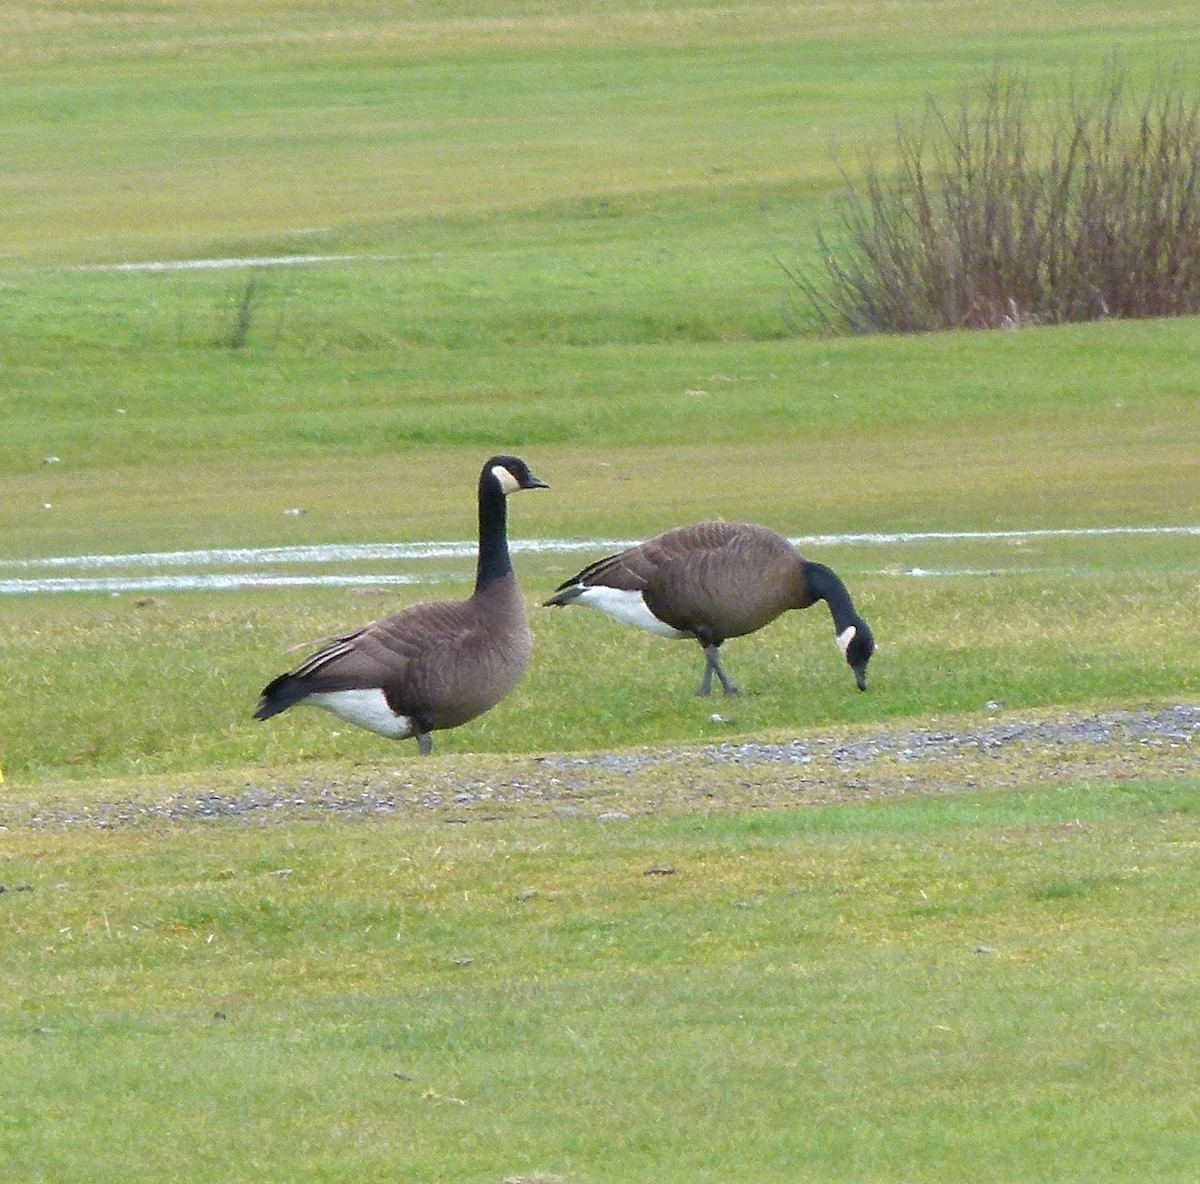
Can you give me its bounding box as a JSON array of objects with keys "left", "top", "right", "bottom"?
[{"left": 545, "top": 522, "right": 875, "bottom": 695}]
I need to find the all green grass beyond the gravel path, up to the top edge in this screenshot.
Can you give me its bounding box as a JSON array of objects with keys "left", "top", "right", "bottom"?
[{"left": 0, "top": 4, "right": 1200, "bottom": 782}]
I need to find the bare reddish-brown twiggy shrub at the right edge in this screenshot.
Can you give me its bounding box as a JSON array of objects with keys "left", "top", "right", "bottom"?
[{"left": 788, "top": 70, "right": 1200, "bottom": 333}]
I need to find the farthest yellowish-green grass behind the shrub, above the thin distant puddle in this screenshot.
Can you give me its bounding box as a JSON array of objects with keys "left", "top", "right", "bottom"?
[{"left": 7, "top": 2, "right": 1196, "bottom": 262}]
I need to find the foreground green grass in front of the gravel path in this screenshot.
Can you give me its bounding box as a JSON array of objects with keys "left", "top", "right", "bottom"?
[{"left": 7, "top": 783, "right": 1200, "bottom": 1184}]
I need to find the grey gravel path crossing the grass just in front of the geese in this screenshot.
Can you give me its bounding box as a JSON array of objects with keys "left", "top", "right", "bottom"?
[{"left": 11, "top": 704, "right": 1200, "bottom": 828}]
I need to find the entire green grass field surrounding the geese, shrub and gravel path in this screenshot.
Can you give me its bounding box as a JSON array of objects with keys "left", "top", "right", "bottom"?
[{"left": 0, "top": 0, "right": 1200, "bottom": 1184}]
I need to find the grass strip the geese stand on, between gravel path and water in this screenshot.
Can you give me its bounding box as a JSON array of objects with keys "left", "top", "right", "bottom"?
[{"left": 0, "top": 559, "right": 1200, "bottom": 785}]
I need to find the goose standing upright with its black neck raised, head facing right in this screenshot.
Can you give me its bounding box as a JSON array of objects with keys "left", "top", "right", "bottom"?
[{"left": 254, "top": 456, "right": 548, "bottom": 756}]
